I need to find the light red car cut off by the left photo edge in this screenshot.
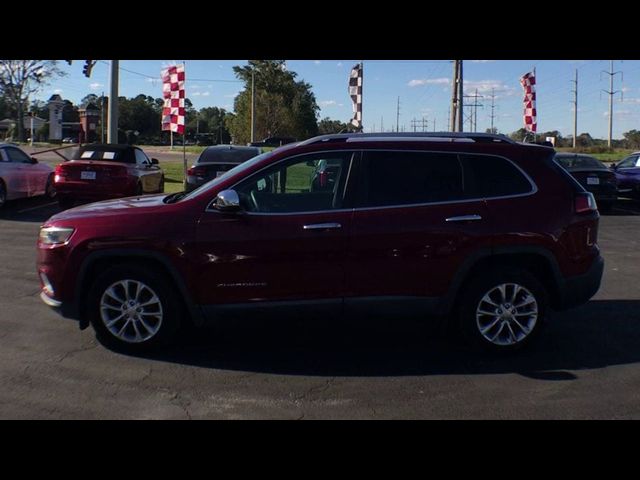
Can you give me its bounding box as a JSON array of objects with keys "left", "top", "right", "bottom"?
[{"left": 0, "top": 143, "right": 56, "bottom": 208}]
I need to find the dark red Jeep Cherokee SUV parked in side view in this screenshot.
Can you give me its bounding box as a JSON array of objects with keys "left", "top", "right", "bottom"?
[{"left": 37, "top": 133, "right": 604, "bottom": 351}]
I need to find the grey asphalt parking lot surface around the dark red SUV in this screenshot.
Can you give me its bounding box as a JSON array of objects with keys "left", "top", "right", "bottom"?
[{"left": 0, "top": 199, "right": 640, "bottom": 419}]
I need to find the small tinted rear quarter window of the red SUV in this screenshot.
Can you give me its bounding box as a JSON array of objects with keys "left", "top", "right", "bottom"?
[{"left": 460, "top": 155, "right": 533, "bottom": 197}]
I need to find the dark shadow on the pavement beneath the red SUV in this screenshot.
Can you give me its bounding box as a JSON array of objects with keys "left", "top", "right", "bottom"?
[{"left": 129, "top": 300, "right": 640, "bottom": 381}]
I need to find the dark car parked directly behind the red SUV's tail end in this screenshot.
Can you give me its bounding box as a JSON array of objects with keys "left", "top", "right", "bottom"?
[{"left": 556, "top": 153, "right": 618, "bottom": 211}]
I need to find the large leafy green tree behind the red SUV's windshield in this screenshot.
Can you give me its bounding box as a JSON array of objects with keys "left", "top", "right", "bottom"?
[{"left": 226, "top": 60, "right": 320, "bottom": 143}]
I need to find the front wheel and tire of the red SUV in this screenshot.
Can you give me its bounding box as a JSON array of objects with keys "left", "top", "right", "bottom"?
[{"left": 87, "top": 265, "right": 181, "bottom": 353}]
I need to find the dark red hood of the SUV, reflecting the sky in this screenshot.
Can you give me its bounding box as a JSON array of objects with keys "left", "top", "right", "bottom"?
[{"left": 49, "top": 193, "right": 167, "bottom": 222}]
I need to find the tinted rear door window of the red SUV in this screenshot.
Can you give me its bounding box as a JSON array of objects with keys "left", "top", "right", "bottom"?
[{"left": 356, "top": 152, "right": 465, "bottom": 207}]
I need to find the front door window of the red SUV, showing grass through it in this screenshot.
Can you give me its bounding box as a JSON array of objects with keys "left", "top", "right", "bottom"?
[{"left": 235, "top": 152, "right": 353, "bottom": 213}]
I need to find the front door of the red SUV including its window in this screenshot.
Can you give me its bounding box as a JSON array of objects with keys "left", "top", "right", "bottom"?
[{"left": 195, "top": 152, "right": 352, "bottom": 314}]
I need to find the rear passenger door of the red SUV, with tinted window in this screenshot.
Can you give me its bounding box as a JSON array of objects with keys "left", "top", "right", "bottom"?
[{"left": 346, "top": 151, "right": 490, "bottom": 307}]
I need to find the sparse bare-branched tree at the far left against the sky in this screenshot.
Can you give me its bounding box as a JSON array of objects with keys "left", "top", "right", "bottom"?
[{"left": 0, "top": 60, "right": 64, "bottom": 141}]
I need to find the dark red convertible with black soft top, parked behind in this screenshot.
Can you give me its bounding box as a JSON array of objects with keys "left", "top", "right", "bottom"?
[{"left": 54, "top": 144, "right": 164, "bottom": 208}]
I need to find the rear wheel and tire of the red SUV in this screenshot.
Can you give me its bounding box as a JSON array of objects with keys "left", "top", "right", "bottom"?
[{"left": 458, "top": 268, "right": 549, "bottom": 353}]
